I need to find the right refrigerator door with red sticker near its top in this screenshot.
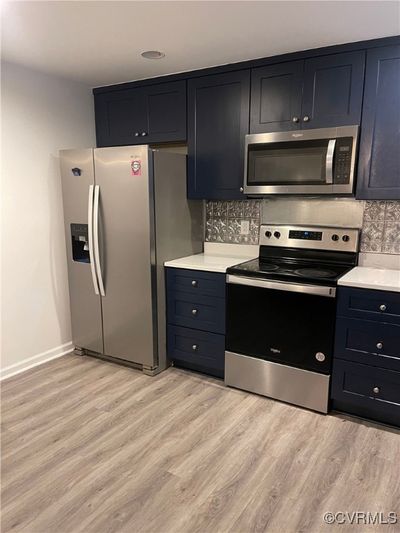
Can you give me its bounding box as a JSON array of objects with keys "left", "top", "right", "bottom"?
[{"left": 94, "top": 146, "right": 157, "bottom": 367}]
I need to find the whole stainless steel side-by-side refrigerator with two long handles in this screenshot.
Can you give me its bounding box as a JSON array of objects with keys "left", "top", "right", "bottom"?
[{"left": 60, "top": 146, "right": 203, "bottom": 374}]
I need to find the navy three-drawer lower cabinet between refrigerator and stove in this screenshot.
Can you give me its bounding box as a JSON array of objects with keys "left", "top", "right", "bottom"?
[{"left": 166, "top": 268, "right": 225, "bottom": 378}]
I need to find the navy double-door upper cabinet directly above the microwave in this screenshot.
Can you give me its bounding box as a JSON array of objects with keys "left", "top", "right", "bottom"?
[{"left": 250, "top": 51, "right": 365, "bottom": 133}]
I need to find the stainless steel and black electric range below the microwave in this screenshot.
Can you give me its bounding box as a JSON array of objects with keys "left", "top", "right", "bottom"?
[{"left": 225, "top": 225, "right": 359, "bottom": 413}]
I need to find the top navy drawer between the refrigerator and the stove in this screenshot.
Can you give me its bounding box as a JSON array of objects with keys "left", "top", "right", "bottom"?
[{"left": 167, "top": 268, "right": 225, "bottom": 301}]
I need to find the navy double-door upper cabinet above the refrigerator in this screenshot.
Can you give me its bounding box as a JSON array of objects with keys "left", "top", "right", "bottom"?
[{"left": 95, "top": 81, "right": 186, "bottom": 146}]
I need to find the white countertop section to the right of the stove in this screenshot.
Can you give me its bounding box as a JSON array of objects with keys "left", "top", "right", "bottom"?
[{"left": 338, "top": 267, "right": 400, "bottom": 292}]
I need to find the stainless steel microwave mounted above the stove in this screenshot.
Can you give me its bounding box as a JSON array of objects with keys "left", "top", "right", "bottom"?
[{"left": 243, "top": 126, "right": 358, "bottom": 195}]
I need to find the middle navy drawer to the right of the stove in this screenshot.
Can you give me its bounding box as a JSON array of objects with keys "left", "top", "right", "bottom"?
[{"left": 334, "top": 318, "right": 400, "bottom": 371}]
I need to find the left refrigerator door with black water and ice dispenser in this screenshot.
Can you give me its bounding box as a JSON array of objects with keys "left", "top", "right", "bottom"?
[{"left": 60, "top": 149, "right": 103, "bottom": 353}]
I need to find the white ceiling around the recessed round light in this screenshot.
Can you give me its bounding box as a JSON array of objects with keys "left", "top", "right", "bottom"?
[{"left": 2, "top": 1, "right": 400, "bottom": 86}]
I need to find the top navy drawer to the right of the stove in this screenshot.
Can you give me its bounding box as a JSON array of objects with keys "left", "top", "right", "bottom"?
[{"left": 337, "top": 287, "right": 400, "bottom": 325}]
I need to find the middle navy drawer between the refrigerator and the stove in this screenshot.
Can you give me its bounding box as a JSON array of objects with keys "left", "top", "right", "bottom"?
[{"left": 168, "top": 292, "right": 225, "bottom": 334}]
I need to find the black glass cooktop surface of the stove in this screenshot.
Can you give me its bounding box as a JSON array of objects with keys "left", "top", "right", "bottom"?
[{"left": 227, "top": 258, "right": 353, "bottom": 286}]
